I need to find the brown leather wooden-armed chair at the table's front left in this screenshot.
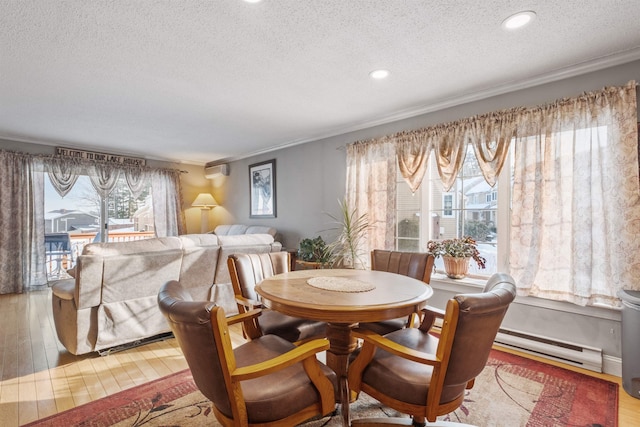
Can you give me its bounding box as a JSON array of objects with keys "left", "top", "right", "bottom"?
[{"left": 158, "top": 281, "right": 337, "bottom": 427}]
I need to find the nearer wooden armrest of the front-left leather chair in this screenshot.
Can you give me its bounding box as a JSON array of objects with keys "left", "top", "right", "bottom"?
[{"left": 231, "top": 339, "right": 329, "bottom": 381}]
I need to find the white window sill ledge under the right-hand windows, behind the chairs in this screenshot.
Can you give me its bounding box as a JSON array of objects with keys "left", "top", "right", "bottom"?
[{"left": 430, "top": 273, "right": 620, "bottom": 321}]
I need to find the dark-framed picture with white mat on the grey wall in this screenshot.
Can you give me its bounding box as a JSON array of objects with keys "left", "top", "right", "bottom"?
[{"left": 249, "top": 159, "right": 276, "bottom": 218}]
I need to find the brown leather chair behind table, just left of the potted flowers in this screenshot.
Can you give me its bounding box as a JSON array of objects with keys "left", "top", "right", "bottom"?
[{"left": 360, "top": 249, "right": 434, "bottom": 335}]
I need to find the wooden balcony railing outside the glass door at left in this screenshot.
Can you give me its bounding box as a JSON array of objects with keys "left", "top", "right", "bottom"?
[{"left": 46, "top": 231, "right": 155, "bottom": 280}]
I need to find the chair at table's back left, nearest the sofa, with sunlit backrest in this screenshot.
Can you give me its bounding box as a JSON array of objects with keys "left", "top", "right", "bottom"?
[{"left": 227, "top": 251, "right": 327, "bottom": 342}]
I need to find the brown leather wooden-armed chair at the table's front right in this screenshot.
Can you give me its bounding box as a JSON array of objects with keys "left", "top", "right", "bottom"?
[{"left": 348, "top": 274, "right": 516, "bottom": 426}]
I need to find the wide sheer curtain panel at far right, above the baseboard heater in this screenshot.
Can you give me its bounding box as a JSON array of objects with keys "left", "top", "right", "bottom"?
[{"left": 509, "top": 82, "right": 640, "bottom": 306}]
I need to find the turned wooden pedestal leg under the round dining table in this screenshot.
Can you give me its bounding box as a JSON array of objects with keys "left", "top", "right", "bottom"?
[{"left": 327, "top": 323, "right": 358, "bottom": 427}]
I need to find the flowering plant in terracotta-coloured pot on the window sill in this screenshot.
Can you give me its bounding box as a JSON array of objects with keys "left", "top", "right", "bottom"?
[{"left": 427, "top": 236, "right": 487, "bottom": 279}]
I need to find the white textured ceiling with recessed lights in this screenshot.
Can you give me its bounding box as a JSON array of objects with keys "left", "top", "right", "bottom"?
[{"left": 0, "top": 0, "right": 640, "bottom": 164}]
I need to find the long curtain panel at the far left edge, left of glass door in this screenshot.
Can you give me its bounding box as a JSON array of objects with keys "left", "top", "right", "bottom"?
[{"left": 0, "top": 151, "right": 47, "bottom": 294}]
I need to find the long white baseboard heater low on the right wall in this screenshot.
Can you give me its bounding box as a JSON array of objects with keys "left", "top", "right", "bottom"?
[{"left": 495, "top": 328, "right": 602, "bottom": 372}]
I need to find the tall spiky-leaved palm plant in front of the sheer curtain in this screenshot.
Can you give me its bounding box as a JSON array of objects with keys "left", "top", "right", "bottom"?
[{"left": 327, "top": 199, "right": 369, "bottom": 268}]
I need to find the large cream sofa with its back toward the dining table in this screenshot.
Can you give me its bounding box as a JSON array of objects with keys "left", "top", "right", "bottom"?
[{"left": 52, "top": 233, "right": 282, "bottom": 354}]
